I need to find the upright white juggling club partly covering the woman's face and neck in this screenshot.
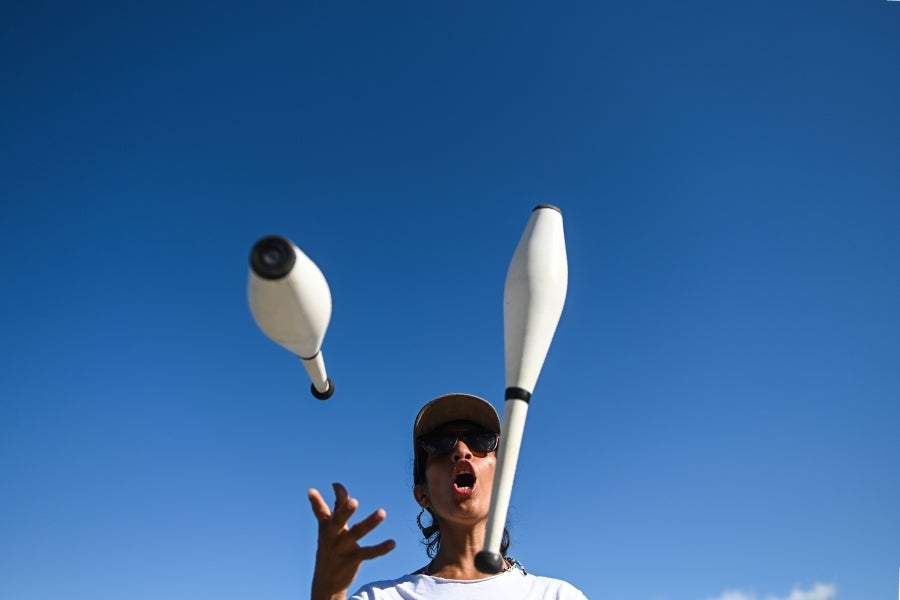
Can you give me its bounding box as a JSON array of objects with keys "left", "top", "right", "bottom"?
[{"left": 475, "top": 204, "right": 569, "bottom": 573}]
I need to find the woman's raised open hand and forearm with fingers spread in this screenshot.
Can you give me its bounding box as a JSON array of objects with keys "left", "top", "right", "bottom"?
[{"left": 309, "top": 483, "right": 396, "bottom": 600}]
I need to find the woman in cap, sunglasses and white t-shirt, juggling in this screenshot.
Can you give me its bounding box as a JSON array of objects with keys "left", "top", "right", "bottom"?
[{"left": 309, "top": 394, "right": 586, "bottom": 600}]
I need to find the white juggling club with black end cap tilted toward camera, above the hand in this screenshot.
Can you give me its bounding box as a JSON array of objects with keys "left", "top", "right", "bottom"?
[{"left": 247, "top": 235, "right": 334, "bottom": 400}]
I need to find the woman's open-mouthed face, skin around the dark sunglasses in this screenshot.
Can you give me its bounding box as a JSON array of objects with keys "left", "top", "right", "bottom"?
[{"left": 416, "top": 423, "right": 497, "bottom": 528}]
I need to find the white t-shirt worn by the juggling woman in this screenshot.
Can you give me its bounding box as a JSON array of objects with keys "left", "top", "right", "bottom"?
[{"left": 351, "top": 569, "right": 587, "bottom": 600}]
